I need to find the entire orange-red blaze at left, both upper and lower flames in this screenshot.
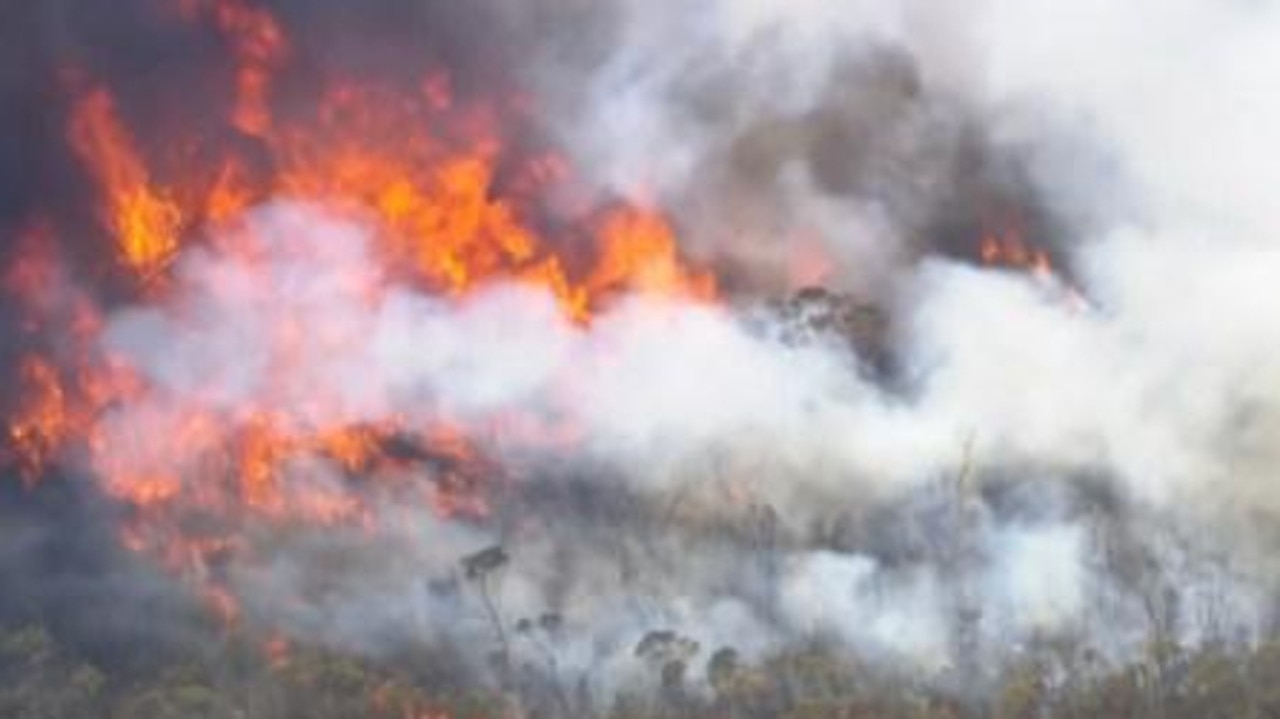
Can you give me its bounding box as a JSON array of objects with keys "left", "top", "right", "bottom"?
[{"left": 8, "top": 0, "right": 717, "bottom": 622}]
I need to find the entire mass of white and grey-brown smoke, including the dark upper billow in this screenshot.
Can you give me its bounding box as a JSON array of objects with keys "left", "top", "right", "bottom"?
[{"left": 0, "top": 0, "right": 1280, "bottom": 691}]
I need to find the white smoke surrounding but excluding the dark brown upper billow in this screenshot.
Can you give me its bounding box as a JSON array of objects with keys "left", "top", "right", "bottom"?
[{"left": 85, "top": 0, "right": 1280, "bottom": 695}]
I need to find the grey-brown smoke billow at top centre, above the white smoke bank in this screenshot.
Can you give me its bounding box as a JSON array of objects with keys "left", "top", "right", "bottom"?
[{"left": 519, "top": 3, "right": 1119, "bottom": 296}]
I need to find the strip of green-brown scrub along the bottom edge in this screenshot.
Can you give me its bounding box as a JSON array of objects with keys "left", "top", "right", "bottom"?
[{"left": 0, "top": 626, "right": 1280, "bottom": 719}]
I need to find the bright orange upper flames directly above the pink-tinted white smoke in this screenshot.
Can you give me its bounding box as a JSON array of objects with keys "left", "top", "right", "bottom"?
[{"left": 64, "top": 70, "right": 716, "bottom": 321}]
